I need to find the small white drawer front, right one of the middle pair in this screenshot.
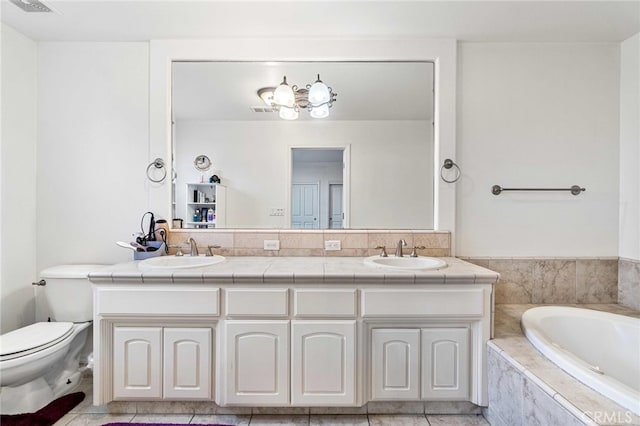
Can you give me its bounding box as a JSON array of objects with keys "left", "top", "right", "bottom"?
[{"left": 293, "top": 289, "right": 358, "bottom": 318}]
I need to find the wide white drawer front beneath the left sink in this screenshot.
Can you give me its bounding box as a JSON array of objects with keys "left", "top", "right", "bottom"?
[{"left": 95, "top": 286, "right": 220, "bottom": 315}]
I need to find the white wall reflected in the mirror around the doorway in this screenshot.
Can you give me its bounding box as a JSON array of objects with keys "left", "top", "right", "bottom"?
[{"left": 175, "top": 121, "right": 433, "bottom": 229}]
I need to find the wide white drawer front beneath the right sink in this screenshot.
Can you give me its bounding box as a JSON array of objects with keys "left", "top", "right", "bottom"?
[{"left": 362, "top": 288, "right": 485, "bottom": 318}]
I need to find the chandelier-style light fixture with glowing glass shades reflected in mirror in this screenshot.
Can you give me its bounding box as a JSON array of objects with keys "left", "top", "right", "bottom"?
[{"left": 258, "top": 74, "right": 338, "bottom": 120}]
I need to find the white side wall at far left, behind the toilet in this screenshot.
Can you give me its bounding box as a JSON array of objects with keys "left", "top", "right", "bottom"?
[{"left": 0, "top": 24, "right": 37, "bottom": 333}]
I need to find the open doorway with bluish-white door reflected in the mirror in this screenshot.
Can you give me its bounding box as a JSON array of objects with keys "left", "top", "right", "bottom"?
[{"left": 291, "top": 148, "right": 347, "bottom": 229}]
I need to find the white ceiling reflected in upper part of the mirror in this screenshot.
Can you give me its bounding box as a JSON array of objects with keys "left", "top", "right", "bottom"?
[{"left": 171, "top": 62, "right": 433, "bottom": 122}]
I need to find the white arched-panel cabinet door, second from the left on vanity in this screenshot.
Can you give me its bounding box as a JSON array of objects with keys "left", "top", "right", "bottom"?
[{"left": 163, "top": 328, "right": 212, "bottom": 399}]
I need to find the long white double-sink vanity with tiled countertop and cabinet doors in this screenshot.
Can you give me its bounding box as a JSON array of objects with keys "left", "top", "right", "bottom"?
[{"left": 90, "top": 257, "right": 498, "bottom": 407}]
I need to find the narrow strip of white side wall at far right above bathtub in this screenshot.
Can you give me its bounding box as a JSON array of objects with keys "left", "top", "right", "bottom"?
[{"left": 619, "top": 34, "right": 640, "bottom": 260}]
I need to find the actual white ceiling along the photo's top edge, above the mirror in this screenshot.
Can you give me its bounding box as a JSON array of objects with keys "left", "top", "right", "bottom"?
[{"left": 0, "top": 0, "right": 640, "bottom": 42}]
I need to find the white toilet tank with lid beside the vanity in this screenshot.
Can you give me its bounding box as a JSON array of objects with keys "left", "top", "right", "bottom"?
[{"left": 39, "top": 265, "right": 106, "bottom": 322}]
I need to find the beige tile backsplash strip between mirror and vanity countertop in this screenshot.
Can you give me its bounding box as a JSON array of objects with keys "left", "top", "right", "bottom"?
[{"left": 169, "top": 229, "right": 451, "bottom": 257}]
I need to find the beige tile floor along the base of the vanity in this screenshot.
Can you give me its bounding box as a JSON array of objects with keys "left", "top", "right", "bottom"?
[{"left": 54, "top": 379, "right": 489, "bottom": 426}]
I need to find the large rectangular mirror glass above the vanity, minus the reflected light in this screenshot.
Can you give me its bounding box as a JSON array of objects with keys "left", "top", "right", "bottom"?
[{"left": 172, "top": 62, "right": 434, "bottom": 229}]
